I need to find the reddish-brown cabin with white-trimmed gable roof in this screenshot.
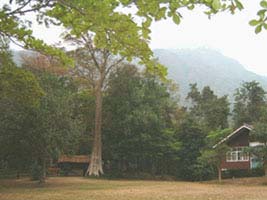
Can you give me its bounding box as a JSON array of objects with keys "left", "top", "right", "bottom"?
[{"left": 214, "top": 124, "right": 261, "bottom": 171}]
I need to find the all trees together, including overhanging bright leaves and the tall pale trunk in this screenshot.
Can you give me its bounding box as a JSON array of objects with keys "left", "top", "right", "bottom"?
[{"left": 0, "top": 0, "right": 267, "bottom": 186}]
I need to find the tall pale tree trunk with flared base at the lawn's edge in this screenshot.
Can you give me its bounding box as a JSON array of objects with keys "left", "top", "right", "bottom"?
[{"left": 86, "top": 81, "right": 104, "bottom": 176}]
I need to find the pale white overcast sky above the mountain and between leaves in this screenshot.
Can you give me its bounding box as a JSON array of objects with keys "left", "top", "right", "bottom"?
[{"left": 7, "top": 0, "right": 267, "bottom": 76}]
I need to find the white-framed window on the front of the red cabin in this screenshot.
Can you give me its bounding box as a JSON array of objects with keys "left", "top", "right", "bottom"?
[{"left": 226, "top": 146, "right": 249, "bottom": 162}]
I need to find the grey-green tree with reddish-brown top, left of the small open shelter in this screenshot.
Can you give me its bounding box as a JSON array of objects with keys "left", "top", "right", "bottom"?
[{"left": 23, "top": 55, "right": 81, "bottom": 181}]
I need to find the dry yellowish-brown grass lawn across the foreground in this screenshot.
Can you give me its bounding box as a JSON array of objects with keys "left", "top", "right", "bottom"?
[{"left": 0, "top": 177, "right": 267, "bottom": 200}]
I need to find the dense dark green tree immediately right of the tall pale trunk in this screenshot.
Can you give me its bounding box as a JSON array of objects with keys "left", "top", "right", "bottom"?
[{"left": 103, "top": 65, "right": 180, "bottom": 175}]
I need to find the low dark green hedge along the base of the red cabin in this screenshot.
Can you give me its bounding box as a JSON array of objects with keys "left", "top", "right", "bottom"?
[{"left": 222, "top": 168, "right": 264, "bottom": 178}]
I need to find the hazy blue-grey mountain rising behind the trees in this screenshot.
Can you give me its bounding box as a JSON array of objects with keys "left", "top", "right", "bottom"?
[{"left": 154, "top": 48, "right": 267, "bottom": 103}]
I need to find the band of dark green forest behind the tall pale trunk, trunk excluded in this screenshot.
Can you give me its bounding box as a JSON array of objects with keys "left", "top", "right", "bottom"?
[{"left": 0, "top": 38, "right": 267, "bottom": 181}]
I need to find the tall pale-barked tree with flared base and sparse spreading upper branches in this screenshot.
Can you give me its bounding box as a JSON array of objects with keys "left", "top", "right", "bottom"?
[{"left": 68, "top": 43, "right": 135, "bottom": 176}]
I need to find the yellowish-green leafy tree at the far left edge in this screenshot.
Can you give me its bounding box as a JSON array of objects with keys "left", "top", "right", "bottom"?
[{"left": 0, "top": 53, "right": 44, "bottom": 175}]
